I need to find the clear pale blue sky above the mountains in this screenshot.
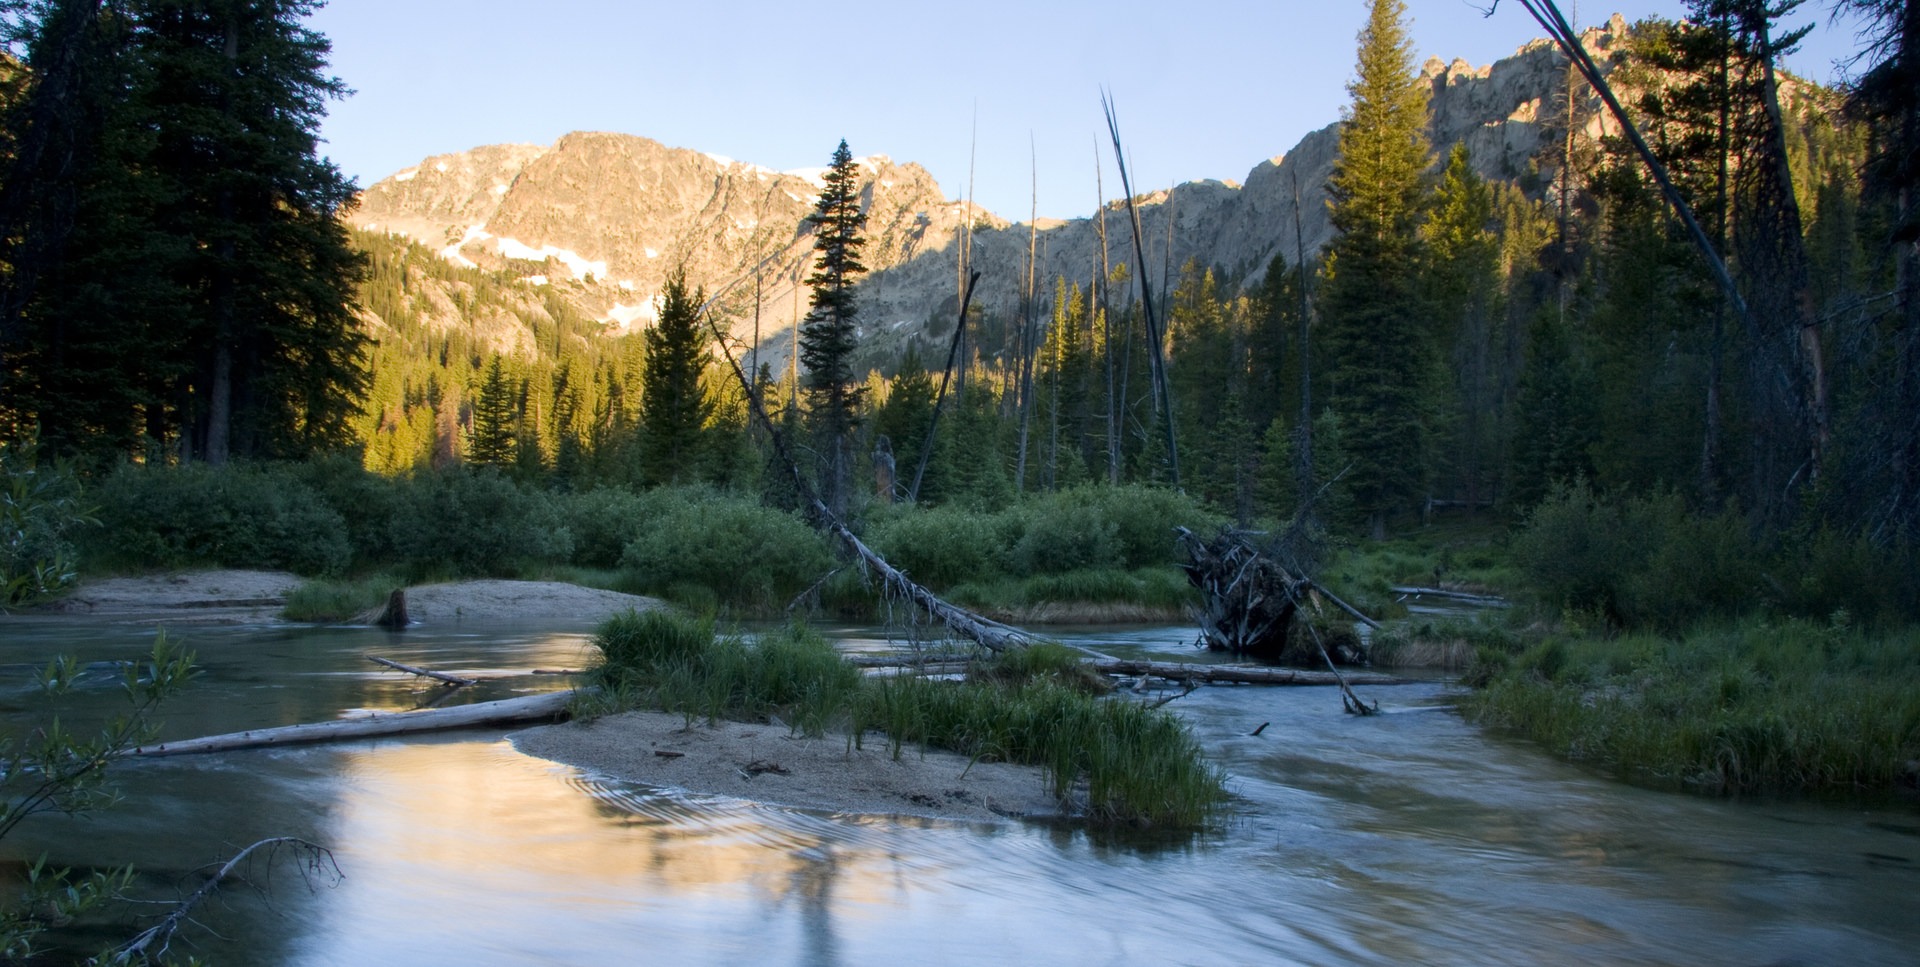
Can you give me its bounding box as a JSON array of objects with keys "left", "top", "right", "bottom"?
[{"left": 309, "top": 0, "right": 1859, "bottom": 221}]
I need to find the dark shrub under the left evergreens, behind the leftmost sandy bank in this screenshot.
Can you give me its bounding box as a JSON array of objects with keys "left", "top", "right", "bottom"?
[{"left": 84, "top": 464, "right": 353, "bottom": 574}]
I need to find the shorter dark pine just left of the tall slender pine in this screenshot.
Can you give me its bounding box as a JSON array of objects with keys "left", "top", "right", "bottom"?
[{"left": 639, "top": 267, "right": 712, "bottom": 484}]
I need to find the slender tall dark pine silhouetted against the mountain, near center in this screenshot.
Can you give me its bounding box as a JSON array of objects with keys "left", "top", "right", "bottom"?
[{"left": 801, "top": 140, "right": 866, "bottom": 514}]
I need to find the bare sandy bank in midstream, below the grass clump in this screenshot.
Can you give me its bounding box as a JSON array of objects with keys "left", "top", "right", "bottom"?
[{"left": 511, "top": 712, "right": 1060, "bottom": 821}]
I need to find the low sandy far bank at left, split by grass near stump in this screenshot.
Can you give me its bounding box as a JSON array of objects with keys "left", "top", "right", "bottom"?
[{"left": 23, "top": 570, "right": 664, "bottom": 625}]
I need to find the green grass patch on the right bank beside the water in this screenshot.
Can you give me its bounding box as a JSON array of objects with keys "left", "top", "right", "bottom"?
[{"left": 1463, "top": 616, "right": 1920, "bottom": 792}]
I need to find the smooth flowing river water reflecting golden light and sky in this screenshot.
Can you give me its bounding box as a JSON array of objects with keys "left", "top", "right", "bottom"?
[{"left": 0, "top": 618, "right": 1920, "bottom": 965}]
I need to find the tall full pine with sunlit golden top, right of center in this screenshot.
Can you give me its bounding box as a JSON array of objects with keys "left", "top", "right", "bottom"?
[{"left": 1323, "top": 0, "right": 1432, "bottom": 537}]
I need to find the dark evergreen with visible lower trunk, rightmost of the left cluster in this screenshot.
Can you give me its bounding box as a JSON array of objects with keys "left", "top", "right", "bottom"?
[{"left": 138, "top": 0, "right": 365, "bottom": 462}]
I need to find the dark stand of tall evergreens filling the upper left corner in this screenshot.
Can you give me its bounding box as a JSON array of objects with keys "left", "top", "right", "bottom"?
[{"left": 0, "top": 0, "right": 365, "bottom": 460}]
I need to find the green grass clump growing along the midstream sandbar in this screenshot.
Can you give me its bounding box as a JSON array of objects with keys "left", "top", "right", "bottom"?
[{"left": 578, "top": 610, "right": 1227, "bottom": 827}]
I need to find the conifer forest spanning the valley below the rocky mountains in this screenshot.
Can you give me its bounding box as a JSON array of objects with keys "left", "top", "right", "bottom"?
[{"left": 0, "top": 0, "right": 1920, "bottom": 629}]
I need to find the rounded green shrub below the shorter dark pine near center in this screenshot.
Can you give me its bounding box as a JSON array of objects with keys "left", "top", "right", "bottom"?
[{"left": 620, "top": 487, "right": 833, "bottom": 606}]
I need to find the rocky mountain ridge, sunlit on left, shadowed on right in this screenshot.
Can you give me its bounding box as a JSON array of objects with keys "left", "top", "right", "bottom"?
[{"left": 349, "top": 15, "right": 1628, "bottom": 366}]
